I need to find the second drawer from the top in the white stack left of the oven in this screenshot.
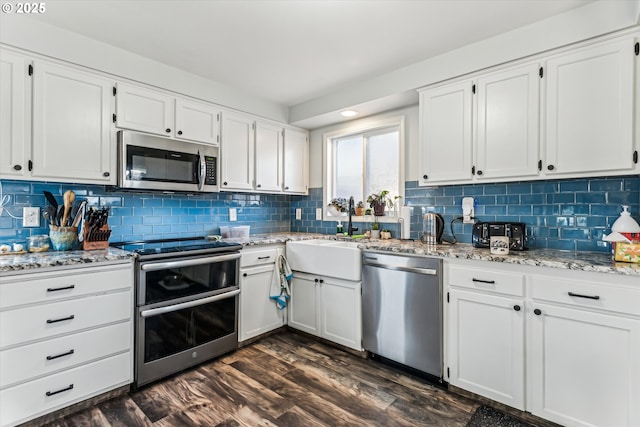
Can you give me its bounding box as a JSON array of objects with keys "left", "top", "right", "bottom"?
[{"left": 0, "top": 291, "right": 133, "bottom": 348}]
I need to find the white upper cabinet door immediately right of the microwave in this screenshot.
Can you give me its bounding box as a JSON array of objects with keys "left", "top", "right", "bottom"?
[{"left": 220, "top": 113, "right": 254, "bottom": 190}]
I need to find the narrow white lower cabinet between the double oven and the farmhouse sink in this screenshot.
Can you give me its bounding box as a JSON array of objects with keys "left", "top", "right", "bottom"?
[{"left": 238, "top": 245, "right": 286, "bottom": 342}]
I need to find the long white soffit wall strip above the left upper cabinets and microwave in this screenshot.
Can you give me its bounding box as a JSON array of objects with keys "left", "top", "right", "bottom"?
[{"left": 0, "top": 13, "right": 288, "bottom": 123}]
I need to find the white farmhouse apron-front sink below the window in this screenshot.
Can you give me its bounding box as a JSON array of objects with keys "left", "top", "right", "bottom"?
[{"left": 287, "top": 239, "right": 362, "bottom": 281}]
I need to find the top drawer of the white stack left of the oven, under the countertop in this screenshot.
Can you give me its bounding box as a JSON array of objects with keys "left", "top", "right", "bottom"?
[{"left": 0, "top": 265, "right": 133, "bottom": 309}]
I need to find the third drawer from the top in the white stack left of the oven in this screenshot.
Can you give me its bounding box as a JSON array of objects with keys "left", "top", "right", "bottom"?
[{"left": 0, "top": 322, "right": 133, "bottom": 389}]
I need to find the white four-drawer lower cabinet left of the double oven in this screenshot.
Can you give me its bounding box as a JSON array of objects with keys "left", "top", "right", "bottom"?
[{"left": 0, "top": 263, "right": 134, "bottom": 427}]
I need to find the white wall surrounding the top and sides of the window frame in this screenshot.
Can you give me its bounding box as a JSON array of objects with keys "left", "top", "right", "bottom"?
[{"left": 309, "top": 105, "right": 420, "bottom": 188}]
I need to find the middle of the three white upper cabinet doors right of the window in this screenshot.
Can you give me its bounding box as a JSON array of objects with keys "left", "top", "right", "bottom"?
[{"left": 475, "top": 64, "right": 540, "bottom": 179}]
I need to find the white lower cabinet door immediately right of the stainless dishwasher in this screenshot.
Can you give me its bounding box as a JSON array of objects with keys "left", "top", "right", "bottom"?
[{"left": 448, "top": 289, "right": 524, "bottom": 409}]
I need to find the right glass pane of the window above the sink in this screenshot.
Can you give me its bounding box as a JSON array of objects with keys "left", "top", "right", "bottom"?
[{"left": 366, "top": 130, "right": 400, "bottom": 204}]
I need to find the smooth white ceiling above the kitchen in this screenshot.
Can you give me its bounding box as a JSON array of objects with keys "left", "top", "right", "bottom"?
[{"left": 26, "top": 0, "right": 594, "bottom": 112}]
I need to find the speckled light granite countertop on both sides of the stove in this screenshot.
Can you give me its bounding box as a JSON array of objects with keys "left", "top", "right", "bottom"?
[{"left": 0, "top": 232, "right": 640, "bottom": 277}]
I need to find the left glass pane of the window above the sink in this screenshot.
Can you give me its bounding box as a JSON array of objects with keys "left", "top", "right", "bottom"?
[{"left": 332, "top": 136, "right": 364, "bottom": 202}]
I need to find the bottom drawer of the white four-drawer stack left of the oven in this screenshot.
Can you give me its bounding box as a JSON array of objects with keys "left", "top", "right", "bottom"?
[{"left": 0, "top": 352, "right": 133, "bottom": 426}]
